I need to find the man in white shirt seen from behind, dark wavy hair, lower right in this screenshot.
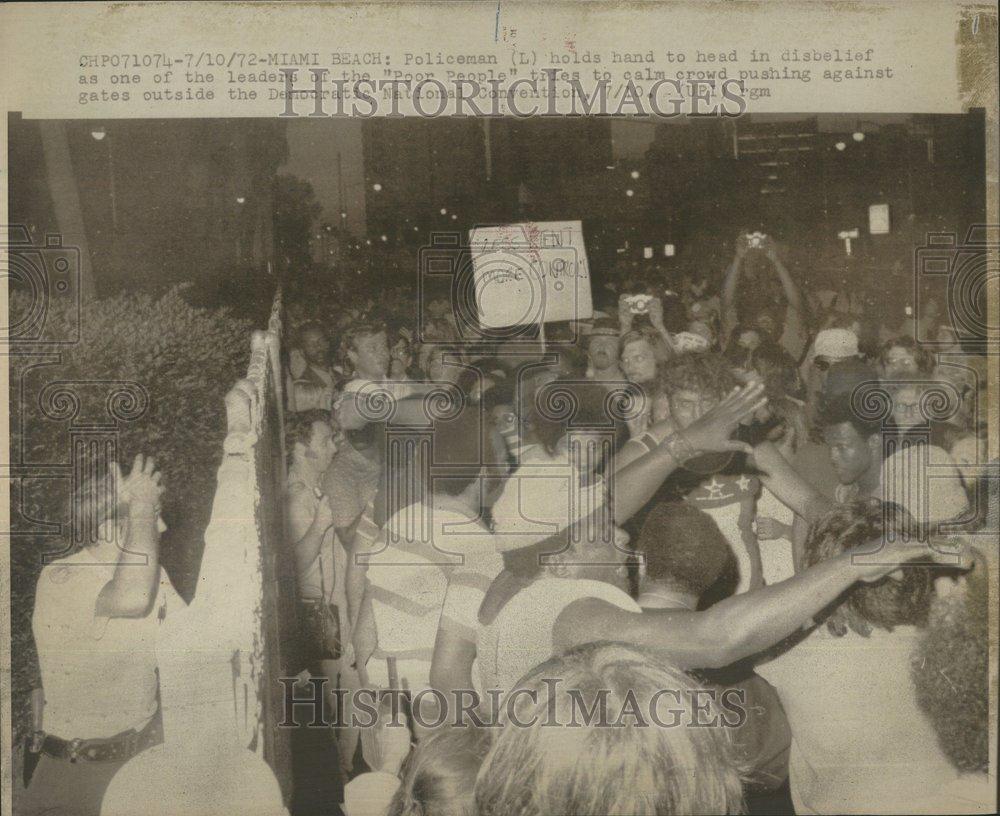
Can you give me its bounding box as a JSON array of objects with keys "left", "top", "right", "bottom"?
[{"left": 757, "top": 499, "right": 972, "bottom": 813}]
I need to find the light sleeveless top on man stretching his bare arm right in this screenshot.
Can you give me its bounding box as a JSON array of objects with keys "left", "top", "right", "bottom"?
[{"left": 477, "top": 577, "right": 642, "bottom": 694}]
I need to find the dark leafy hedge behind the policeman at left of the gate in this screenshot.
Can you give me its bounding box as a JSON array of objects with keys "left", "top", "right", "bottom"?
[{"left": 8, "top": 287, "right": 252, "bottom": 744}]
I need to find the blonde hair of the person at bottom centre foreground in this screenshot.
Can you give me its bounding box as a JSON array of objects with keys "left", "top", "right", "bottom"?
[{"left": 476, "top": 643, "right": 743, "bottom": 816}]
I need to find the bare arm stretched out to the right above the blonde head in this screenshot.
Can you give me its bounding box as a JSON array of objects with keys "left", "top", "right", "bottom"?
[{"left": 553, "top": 538, "right": 954, "bottom": 669}]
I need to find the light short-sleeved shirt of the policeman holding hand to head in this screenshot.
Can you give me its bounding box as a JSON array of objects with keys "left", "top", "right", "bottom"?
[{"left": 32, "top": 550, "right": 184, "bottom": 739}]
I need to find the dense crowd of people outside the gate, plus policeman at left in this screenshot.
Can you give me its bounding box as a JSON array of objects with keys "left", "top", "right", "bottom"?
[{"left": 24, "top": 233, "right": 997, "bottom": 816}]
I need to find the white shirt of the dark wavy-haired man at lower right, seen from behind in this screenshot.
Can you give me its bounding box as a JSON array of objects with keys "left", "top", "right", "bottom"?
[{"left": 757, "top": 624, "right": 958, "bottom": 813}]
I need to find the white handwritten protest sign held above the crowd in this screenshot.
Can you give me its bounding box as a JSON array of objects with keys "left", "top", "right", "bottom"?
[{"left": 469, "top": 221, "right": 594, "bottom": 329}]
